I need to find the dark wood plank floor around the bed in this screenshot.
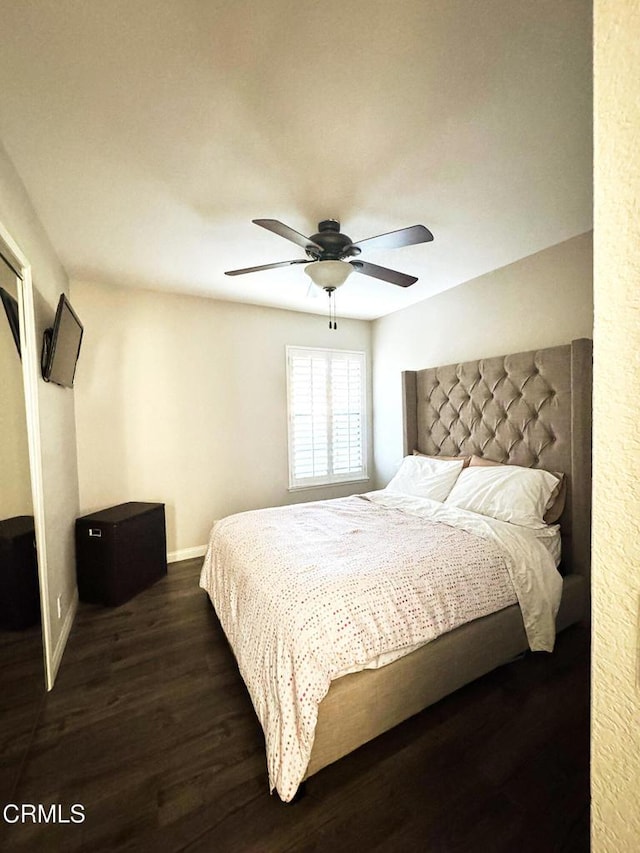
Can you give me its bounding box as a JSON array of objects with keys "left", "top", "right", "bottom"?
[{"left": 0, "top": 560, "right": 589, "bottom": 853}]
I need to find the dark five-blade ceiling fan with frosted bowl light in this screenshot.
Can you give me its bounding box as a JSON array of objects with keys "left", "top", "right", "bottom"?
[{"left": 225, "top": 219, "right": 433, "bottom": 295}]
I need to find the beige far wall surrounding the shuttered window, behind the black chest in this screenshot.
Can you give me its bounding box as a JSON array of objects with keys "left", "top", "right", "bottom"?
[{"left": 71, "top": 282, "right": 370, "bottom": 554}]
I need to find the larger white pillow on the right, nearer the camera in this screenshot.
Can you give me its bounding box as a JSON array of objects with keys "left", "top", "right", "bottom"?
[{"left": 447, "top": 465, "right": 558, "bottom": 528}]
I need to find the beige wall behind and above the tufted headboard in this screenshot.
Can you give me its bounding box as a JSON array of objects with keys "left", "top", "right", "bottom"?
[{"left": 373, "top": 232, "right": 593, "bottom": 486}]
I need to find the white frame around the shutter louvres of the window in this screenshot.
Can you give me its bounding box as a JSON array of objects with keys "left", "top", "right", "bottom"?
[{"left": 286, "top": 346, "right": 369, "bottom": 491}]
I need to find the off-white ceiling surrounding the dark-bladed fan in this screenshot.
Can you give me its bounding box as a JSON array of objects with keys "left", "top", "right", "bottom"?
[{"left": 0, "top": 0, "right": 592, "bottom": 318}]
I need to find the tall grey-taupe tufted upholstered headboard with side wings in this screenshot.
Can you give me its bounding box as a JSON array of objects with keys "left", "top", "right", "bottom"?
[{"left": 402, "top": 338, "right": 592, "bottom": 576}]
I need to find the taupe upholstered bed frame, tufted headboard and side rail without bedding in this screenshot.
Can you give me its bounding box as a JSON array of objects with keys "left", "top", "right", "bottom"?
[{"left": 305, "top": 338, "right": 592, "bottom": 778}]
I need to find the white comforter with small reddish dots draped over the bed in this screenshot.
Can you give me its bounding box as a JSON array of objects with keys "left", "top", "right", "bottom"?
[{"left": 200, "top": 493, "right": 561, "bottom": 801}]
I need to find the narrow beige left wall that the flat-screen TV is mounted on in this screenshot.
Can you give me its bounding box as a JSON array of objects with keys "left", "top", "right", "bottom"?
[{"left": 0, "top": 141, "right": 78, "bottom": 684}]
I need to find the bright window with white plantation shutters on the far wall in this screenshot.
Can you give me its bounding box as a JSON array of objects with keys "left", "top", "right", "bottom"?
[{"left": 287, "top": 347, "right": 367, "bottom": 489}]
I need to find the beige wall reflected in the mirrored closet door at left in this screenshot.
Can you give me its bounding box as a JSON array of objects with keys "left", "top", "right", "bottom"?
[{"left": 0, "top": 270, "right": 33, "bottom": 519}]
